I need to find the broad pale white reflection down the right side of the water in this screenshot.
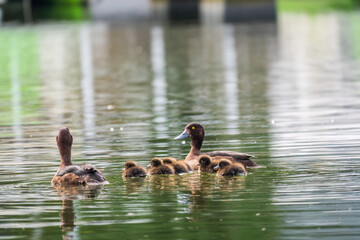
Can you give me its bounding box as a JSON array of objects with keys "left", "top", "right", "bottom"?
[{"left": 269, "top": 13, "right": 360, "bottom": 239}]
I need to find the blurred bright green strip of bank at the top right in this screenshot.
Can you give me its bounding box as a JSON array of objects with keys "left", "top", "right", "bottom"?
[{"left": 277, "top": 0, "right": 356, "bottom": 13}]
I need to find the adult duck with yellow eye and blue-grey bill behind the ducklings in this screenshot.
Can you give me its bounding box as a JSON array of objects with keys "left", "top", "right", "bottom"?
[{"left": 175, "top": 123, "right": 258, "bottom": 167}]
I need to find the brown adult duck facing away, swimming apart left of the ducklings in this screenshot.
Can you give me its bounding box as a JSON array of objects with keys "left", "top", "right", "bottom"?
[{"left": 51, "top": 127, "right": 107, "bottom": 185}]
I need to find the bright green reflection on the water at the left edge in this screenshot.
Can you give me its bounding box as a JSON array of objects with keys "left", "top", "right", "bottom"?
[{"left": 0, "top": 28, "right": 40, "bottom": 125}]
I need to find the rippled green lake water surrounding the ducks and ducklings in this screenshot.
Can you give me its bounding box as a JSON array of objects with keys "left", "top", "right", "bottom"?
[{"left": 0, "top": 12, "right": 360, "bottom": 240}]
